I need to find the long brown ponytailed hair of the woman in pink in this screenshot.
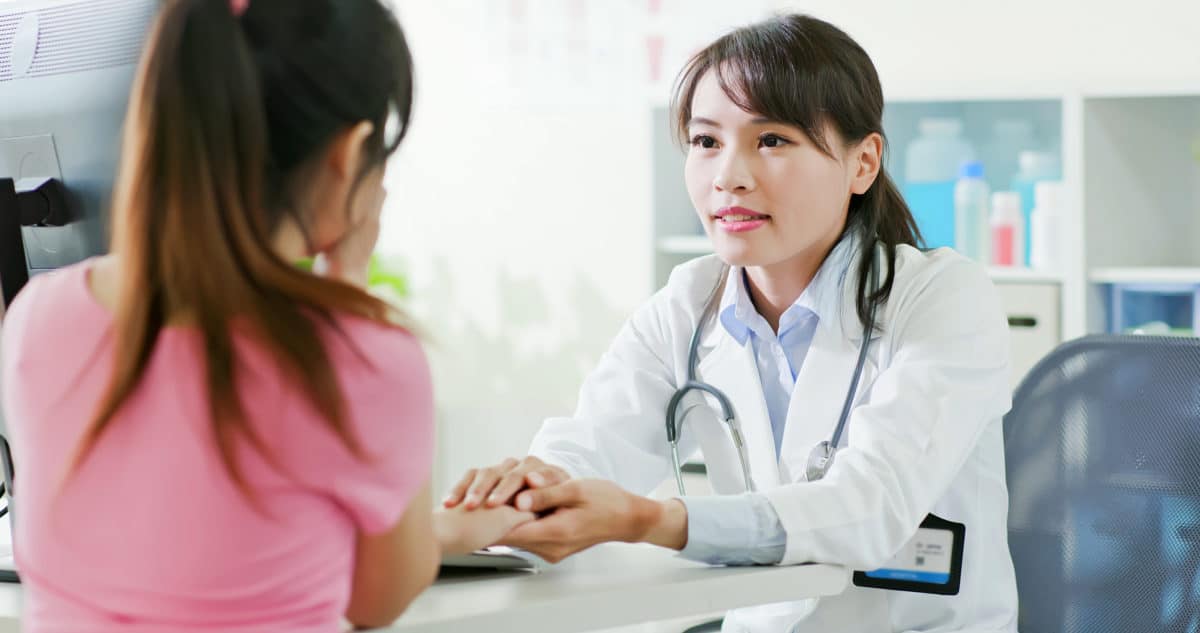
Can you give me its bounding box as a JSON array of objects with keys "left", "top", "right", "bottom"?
[{"left": 70, "top": 0, "right": 413, "bottom": 493}]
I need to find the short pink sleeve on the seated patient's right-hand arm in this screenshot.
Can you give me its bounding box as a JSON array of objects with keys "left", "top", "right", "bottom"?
[{"left": 289, "top": 322, "right": 433, "bottom": 533}]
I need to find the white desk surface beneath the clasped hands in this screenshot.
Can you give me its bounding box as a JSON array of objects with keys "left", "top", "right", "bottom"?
[{"left": 0, "top": 543, "right": 850, "bottom": 633}]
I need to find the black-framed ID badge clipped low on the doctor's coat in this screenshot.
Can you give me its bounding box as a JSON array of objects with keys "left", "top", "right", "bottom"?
[{"left": 854, "top": 514, "right": 967, "bottom": 596}]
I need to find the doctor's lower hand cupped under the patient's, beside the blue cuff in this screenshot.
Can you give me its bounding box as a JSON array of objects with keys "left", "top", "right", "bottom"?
[{"left": 500, "top": 480, "right": 688, "bottom": 562}]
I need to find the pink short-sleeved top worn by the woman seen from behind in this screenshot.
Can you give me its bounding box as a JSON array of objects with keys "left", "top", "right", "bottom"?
[{"left": 2, "top": 263, "right": 433, "bottom": 633}]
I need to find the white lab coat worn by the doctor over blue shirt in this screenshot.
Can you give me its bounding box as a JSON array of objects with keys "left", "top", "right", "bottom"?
[{"left": 530, "top": 239, "right": 1016, "bottom": 633}]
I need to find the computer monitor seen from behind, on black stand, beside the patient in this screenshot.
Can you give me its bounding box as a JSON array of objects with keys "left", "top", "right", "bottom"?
[{"left": 0, "top": 0, "right": 158, "bottom": 579}]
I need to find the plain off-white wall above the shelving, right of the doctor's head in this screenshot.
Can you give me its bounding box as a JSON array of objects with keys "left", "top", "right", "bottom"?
[{"left": 776, "top": 0, "right": 1200, "bottom": 97}]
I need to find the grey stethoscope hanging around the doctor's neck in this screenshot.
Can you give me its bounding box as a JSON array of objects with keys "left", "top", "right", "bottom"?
[{"left": 667, "top": 242, "right": 880, "bottom": 495}]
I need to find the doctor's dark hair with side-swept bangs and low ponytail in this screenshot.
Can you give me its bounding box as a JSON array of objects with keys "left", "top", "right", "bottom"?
[{"left": 671, "top": 14, "right": 922, "bottom": 327}]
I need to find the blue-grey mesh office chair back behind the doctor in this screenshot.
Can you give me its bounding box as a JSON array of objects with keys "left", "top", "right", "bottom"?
[{"left": 1004, "top": 336, "right": 1200, "bottom": 633}]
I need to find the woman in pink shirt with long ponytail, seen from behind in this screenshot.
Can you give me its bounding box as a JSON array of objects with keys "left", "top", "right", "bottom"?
[{"left": 2, "top": 0, "right": 533, "bottom": 633}]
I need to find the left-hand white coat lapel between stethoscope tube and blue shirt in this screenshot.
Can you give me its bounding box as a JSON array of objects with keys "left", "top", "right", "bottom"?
[{"left": 697, "top": 324, "right": 780, "bottom": 490}]
